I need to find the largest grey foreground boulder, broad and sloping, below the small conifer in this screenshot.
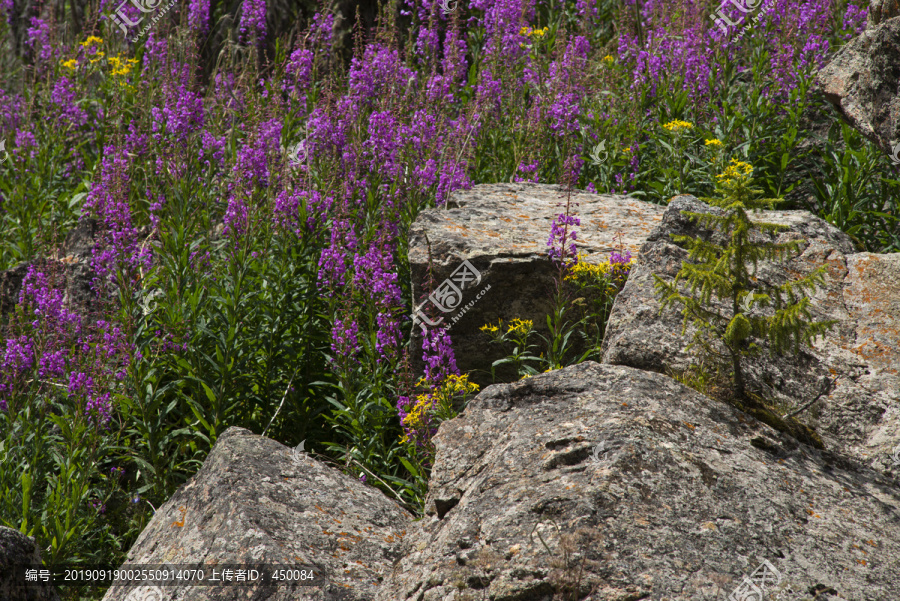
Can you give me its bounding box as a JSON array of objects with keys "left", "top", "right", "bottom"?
[{"left": 375, "top": 362, "right": 900, "bottom": 601}]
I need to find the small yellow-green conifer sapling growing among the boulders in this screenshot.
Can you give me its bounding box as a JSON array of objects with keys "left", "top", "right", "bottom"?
[{"left": 654, "top": 161, "right": 836, "bottom": 399}]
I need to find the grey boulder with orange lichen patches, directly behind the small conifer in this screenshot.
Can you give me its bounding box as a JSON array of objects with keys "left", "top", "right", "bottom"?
[{"left": 603, "top": 195, "right": 900, "bottom": 472}]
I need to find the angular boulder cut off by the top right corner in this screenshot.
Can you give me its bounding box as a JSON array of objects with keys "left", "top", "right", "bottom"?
[{"left": 817, "top": 0, "right": 900, "bottom": 153}]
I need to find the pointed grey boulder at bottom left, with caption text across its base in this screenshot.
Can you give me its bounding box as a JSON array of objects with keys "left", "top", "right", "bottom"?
[{"left": 104, "top": 428, "right": 411, "bottom": 601}]
